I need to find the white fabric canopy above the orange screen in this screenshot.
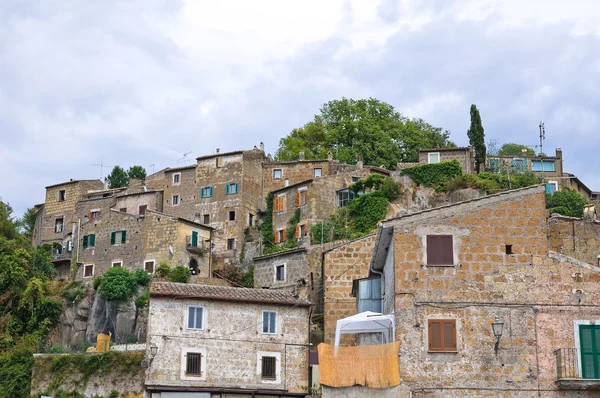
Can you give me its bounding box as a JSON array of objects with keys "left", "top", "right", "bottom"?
[{"left": 335, "top": 311, "right": 396, "bottom": 347}]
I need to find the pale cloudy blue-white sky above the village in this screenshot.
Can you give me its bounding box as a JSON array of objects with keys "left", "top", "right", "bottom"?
[{"left": 0, "top": 0, "right": 600, "bottom": 216}]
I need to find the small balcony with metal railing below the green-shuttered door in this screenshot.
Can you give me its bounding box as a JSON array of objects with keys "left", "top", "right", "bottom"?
[{"left": 554, "top": 348, "right": 600, "bottom": 390}]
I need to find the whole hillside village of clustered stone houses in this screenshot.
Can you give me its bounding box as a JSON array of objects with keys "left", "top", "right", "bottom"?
[{"left": 23, "top": 143, "right": 600, "bottom": 398}]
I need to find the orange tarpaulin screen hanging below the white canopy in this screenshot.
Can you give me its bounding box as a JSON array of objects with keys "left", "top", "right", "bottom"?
[{"left": 318, "top": 341, "right": 400, "bottom": 388}]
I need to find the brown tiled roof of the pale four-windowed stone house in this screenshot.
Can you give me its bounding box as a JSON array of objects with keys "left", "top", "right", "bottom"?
[{"left": 150, "top": 282, "right": 311, "bottom": 307}]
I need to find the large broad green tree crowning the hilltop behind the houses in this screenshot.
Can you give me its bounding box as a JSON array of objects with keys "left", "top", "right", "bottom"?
[{"left": 275, "top": 98, "right": 455, "bottom": 170}]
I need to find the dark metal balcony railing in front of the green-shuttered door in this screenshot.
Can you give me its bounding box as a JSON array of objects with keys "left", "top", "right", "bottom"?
[{"left": 554, "top": 348, "right": 600, "bottom": 380}]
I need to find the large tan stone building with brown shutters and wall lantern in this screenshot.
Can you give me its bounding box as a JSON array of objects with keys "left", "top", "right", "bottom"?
[{"left": 325, "top": 186, "right": 600, "bottom": 398}]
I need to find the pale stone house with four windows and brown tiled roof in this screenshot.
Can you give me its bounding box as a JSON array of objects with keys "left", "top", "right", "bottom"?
[{"left": 146, "top": 282, "right": 310, "bottom": 398}]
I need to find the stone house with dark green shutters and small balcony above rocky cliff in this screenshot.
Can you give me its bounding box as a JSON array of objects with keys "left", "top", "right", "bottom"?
[{"left": 75, "top": 209, "right": 212, "bottom": 280}]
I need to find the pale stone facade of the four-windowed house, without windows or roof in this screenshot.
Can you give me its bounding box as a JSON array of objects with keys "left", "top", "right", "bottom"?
[{"left": 146, "top": 297, "right": 308, "bottom": 392}]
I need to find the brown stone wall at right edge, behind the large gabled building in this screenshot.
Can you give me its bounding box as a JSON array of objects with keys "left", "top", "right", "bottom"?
[{"left": 548, "top": 216, "right": 600, "bottom": 266}]
